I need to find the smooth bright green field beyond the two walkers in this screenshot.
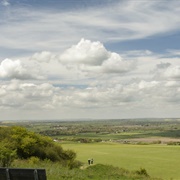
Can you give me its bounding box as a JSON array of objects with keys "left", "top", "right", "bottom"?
[{"left": 62, "top": 143, "right": 180, "bottom": 180}]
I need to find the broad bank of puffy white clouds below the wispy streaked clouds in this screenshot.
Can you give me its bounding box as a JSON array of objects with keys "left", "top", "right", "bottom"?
[{"left": 0, "top": 39, "right": 180, "bottom": 118}]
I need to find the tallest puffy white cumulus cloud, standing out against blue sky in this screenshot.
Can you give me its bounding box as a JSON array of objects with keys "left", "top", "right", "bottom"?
[{"left": 60, "top": 39, "right": 135, "bottom": 73}]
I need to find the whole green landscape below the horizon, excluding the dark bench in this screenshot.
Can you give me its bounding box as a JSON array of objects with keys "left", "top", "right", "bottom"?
[{"left": 0, "top": 119, "right": 180, "bottom": 180}]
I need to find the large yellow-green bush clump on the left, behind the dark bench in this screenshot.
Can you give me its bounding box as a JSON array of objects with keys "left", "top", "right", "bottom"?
[{"left": 0, "top": 127, "right": 79, "bottom": 168}]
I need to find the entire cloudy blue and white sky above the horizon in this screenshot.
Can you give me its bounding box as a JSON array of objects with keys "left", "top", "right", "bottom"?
[{"left": 0, "top": 0, "right": 180, "bottom": 120}]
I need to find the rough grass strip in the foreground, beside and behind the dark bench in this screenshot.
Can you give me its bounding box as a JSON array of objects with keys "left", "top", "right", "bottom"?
[{"left": 13, "top": 160, "right": 155, "bottom": 180}]
